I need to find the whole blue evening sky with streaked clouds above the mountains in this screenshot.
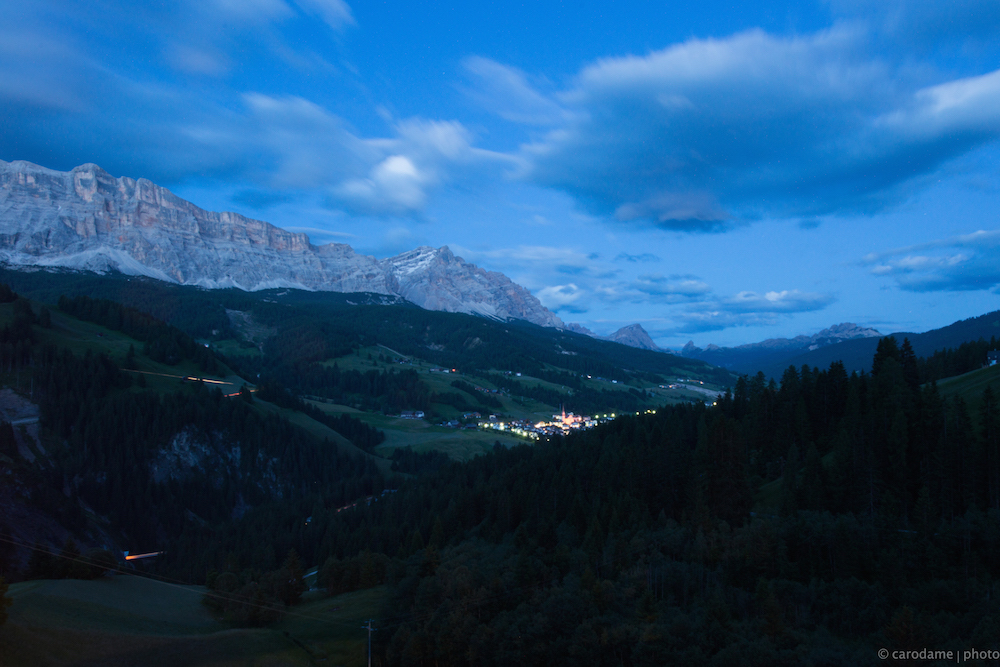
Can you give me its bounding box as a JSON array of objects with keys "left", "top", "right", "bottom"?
[{"left": 0, "top": 0, "right": 1000, "bottom": 347}]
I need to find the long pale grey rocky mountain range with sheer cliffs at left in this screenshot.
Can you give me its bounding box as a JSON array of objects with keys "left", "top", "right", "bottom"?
[{"left": 0, "top": 160, "right": 564, "bottom": 327}]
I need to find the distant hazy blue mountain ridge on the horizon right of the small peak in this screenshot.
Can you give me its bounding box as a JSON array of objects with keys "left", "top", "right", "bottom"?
[{"left": 681, "top": 322, "right": 882, "bottom": 373}]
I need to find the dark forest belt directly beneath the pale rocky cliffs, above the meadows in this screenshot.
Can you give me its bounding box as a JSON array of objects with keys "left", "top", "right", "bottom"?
[{"left": 0, "top": 268, "right": 731, "bottom": 384}]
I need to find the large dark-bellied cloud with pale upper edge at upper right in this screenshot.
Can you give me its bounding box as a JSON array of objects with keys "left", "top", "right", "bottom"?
[{"left": 477, "top": 24, "right": 1000, "bottom": 232}]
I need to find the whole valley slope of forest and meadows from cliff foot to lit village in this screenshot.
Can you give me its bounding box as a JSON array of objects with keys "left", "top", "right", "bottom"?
[{"left": 0, "top": 269, "right": 734, "bottom": 422}]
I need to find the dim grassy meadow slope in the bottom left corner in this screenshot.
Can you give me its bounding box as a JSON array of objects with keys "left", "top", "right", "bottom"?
[{"left": 0, "top": 576, "right": 384, "bottom": 667}]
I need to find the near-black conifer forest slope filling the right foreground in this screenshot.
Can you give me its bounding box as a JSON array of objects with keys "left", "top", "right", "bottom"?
[{"left": 221, "top": 339, "right": 1000, "bottom": 665}]
